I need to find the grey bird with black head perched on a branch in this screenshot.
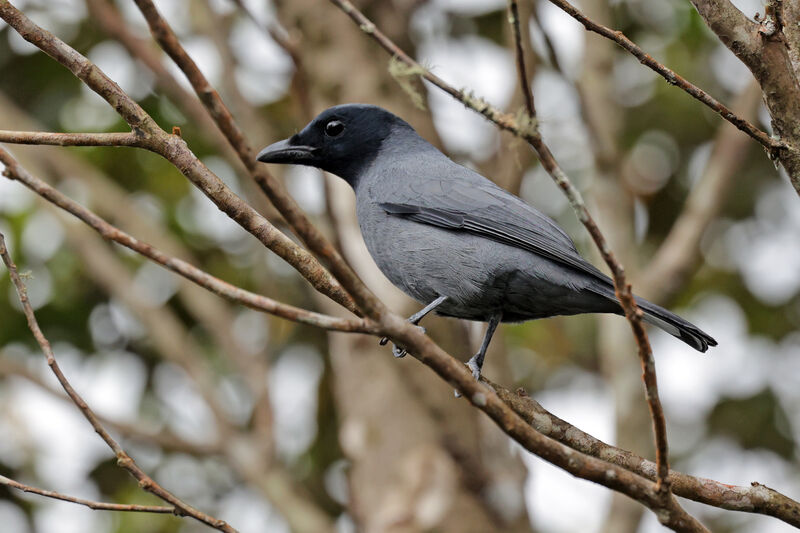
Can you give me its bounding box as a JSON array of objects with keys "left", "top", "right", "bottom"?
[{"left": 257, "top": 104, "right": 717, "bottom": 379}]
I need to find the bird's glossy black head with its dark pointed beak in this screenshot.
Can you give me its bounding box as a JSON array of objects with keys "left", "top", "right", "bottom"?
[{"left": 258, "top": 104, "right": 416, "bottom": 186}]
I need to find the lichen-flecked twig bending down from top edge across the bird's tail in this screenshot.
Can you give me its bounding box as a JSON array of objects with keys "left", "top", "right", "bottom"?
[{"left": 331, "top": 0, "right": 669, "bottom": 494}]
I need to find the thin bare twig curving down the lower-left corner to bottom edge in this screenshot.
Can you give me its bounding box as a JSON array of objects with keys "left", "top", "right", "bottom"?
[{"left": 0, "top": 233, "right": 236, "bottom": 533}]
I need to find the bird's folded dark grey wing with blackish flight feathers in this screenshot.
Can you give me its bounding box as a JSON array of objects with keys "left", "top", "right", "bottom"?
[{"left": 380, "top": 202, "right": 608, "bottom": 281}]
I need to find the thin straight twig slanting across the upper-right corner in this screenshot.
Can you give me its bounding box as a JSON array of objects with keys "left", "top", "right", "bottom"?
[{"left": 550, "top": 0, "right": 785, "bottom": 154}]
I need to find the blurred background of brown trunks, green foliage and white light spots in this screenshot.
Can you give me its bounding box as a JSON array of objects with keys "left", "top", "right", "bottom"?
[{"left": 0, "top": 0, "right": 800, "bottom": 533}]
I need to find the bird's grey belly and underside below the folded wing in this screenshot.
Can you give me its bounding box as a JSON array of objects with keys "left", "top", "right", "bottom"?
[{"left": 358, "top": 206, "right": 607, "bottom": 321}]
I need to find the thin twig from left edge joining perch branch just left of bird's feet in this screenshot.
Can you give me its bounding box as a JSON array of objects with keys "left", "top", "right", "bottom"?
[{"left": 0, "top": 148, "right": 376, "bottom": 333}]
